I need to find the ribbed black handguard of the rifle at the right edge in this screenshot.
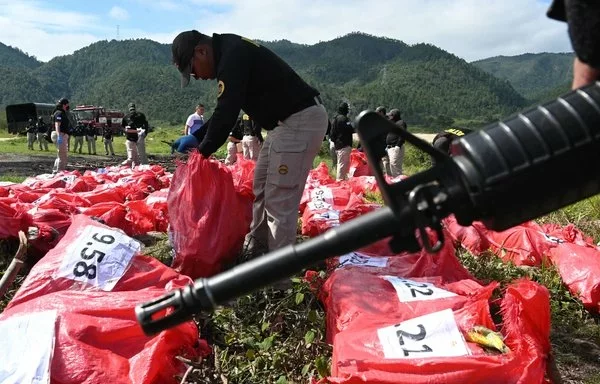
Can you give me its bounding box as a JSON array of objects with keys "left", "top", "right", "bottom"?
[{"left": 451, "top": 82, "right": 600, "bottom": 230}]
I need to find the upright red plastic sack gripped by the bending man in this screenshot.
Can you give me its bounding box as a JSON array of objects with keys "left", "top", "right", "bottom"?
[{"left": 168, "top": 153, "right": 252, "bottom": 279}]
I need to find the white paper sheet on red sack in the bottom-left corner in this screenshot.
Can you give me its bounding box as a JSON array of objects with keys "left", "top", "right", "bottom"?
[{"left": 0, "top": 311, "right": 56, "bottom": 384}]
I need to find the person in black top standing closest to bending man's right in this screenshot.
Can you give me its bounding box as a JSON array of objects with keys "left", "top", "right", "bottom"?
[{"left": 331, "top": 102, "right": 354, "bottom": 181}]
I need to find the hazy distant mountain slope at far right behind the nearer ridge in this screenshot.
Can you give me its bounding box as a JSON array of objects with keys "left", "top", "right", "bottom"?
[{"left": 471, "top": 53, "right": 574, "bottom": 103}]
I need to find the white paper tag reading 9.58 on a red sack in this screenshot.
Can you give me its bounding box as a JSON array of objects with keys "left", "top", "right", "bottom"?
[{"left": 58, "top": 225, "right": 141, "bottom": 291}]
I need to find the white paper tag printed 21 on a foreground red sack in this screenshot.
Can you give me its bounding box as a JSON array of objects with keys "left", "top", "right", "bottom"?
[{"left": 377, "top": 309, "right": 470, "bottom": 359}]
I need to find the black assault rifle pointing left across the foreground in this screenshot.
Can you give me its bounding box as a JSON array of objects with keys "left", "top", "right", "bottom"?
[{"left": 136, "top": 83, "right": 600, "bottom": 335}]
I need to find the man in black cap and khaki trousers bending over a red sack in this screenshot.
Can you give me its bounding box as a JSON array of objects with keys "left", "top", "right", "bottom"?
[{"left": 171, "top": 30, "right": 327, "bottom": 262}]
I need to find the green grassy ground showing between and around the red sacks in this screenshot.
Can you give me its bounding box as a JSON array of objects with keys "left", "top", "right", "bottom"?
[{"left": 0, "top": 127, "right": 600, "bottom": 384}]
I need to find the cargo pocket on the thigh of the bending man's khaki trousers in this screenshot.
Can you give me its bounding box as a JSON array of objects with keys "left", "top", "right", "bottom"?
[{"left": 267, "top": 142, "right": 306, "bottom": 188}]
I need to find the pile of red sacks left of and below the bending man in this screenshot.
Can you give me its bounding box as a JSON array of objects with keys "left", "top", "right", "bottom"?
[{"left": 0, "top": 154, "right": 254, "bottom": 384}]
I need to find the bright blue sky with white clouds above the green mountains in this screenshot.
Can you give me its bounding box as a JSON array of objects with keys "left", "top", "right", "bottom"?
[{"left": 0, "top": 0, "right": 571, "bottom": 61}]
